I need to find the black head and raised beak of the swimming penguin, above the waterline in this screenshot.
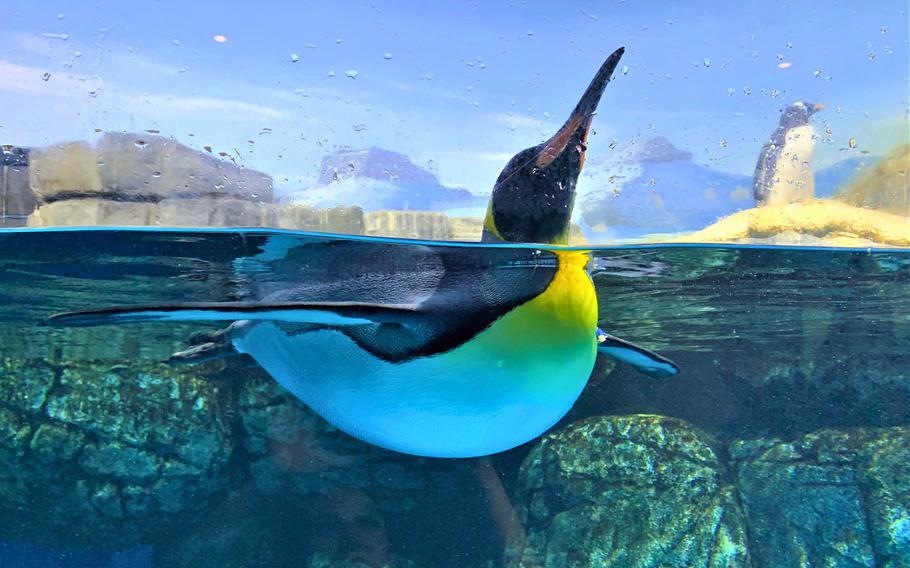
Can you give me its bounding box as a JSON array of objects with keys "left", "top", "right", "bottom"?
[{"left": 483, "top": 48, "right": 625, "bottom": 244}]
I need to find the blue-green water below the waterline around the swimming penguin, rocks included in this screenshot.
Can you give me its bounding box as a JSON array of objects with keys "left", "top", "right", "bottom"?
[{"left": 0, "top": 229, "right": 910, "bottom": 566}]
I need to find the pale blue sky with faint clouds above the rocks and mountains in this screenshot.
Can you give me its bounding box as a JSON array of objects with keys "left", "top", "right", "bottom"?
[{"left": 0, "top": 0, "right": 910, "bottom": 193}]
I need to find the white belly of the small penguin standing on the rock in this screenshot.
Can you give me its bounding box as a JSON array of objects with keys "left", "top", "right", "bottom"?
[{"left": 767, "top": 125, "right": 815, "bottom": 205}]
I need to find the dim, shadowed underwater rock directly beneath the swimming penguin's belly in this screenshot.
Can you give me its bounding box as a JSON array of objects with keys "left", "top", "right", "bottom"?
[{"left": 237, "top": 369, "right": 499, "bottom": 566}]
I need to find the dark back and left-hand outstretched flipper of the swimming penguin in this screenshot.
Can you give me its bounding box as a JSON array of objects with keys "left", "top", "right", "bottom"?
[{"left": 45, "top": 239, "right": 559, "bottom": 362}]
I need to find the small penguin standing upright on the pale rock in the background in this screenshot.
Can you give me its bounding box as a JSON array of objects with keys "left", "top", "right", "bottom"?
[{"left": 752, "top": 101, "right": 824, "bottom": 206}]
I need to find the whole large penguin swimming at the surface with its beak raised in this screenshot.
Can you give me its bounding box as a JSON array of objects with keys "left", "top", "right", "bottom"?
[{"left": 49, "top": 49, "right": 675, "bottom": 457}]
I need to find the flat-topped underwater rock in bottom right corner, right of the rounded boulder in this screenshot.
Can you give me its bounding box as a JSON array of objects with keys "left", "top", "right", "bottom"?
[{"left": 729, "top": 428, "right": 910, "bottom": 567}]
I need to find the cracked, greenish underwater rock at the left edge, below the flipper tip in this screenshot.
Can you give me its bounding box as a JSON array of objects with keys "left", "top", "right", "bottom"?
[{"left": 0, "top": 359, "right": 233, "bottom": 548}]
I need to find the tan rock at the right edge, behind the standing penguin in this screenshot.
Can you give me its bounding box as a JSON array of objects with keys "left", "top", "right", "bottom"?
[{"left": 837, "top": 144, "right": 910, "bottom": 216}]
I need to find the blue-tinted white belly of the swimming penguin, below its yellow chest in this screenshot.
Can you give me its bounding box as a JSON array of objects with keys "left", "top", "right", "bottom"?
[{"left": 234, "top": 306, "right": 596, "bottom": 457}]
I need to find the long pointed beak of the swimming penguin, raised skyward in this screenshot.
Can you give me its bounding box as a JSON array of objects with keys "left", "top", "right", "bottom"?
[{"left": 536, "top": 47, "right": 626, "bottom": 170}]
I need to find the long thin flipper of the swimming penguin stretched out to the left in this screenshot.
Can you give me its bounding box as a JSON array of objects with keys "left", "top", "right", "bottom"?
[{"left": 43, "top": 302, "right": 425, "bottom": 328}]
